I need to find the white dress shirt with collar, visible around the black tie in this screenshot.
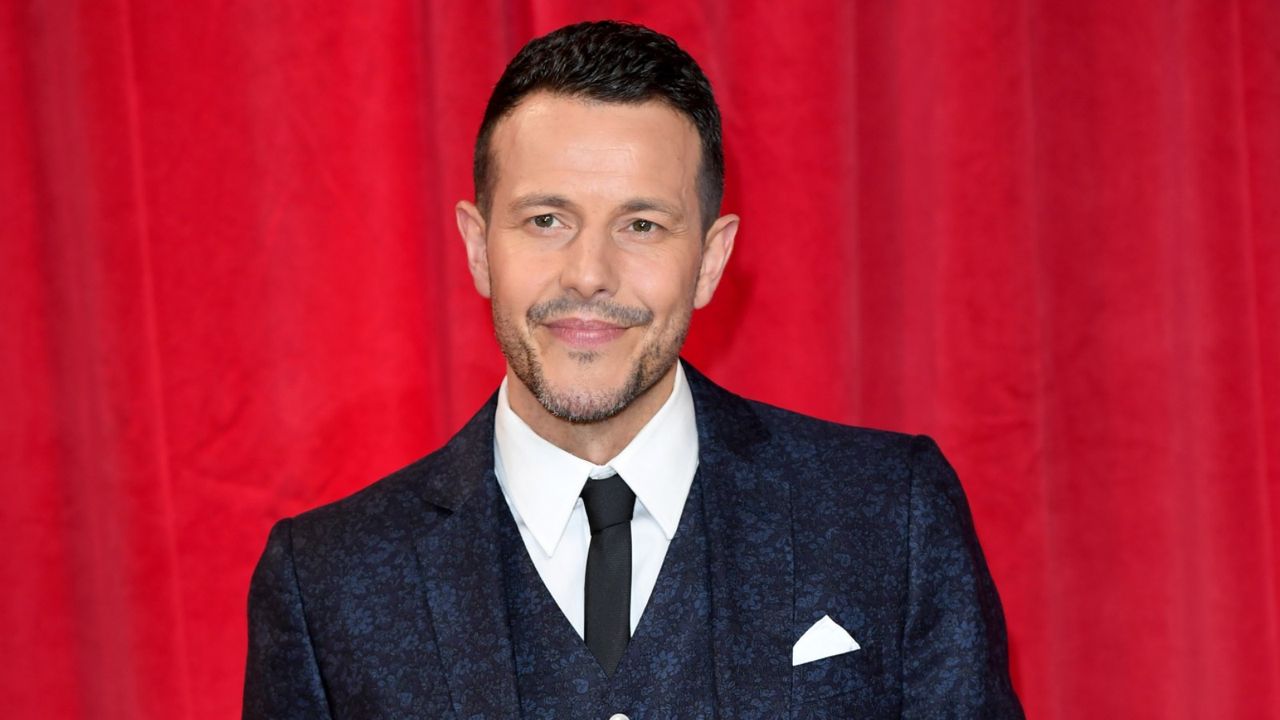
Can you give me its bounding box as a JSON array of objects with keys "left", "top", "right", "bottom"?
[{"left": 493, "top": 363, "right": 698, "bottom": 637}]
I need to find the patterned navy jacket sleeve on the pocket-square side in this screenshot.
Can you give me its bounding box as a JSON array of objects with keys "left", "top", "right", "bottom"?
[{"left": 902, "top": 436, "right": 1024, "bottom": 720}]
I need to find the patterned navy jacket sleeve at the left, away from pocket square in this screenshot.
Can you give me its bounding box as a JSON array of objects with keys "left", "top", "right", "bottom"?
[{"left": 243, "top": 520, "right": 330, "bottom": 720}]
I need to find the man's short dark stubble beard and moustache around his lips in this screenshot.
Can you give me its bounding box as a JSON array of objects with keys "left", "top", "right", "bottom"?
[{"left": 490, "top": 296, "right": 692, "bottom": 424}]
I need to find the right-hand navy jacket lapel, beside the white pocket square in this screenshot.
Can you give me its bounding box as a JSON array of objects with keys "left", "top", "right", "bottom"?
[{"left": 685, "top": 364, "right": 795, "bottom": 717}]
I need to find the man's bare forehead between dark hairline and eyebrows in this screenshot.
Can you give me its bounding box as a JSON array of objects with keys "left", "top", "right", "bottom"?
[{"left": 490, "top": 92, "right": 701, "bottom": 202}]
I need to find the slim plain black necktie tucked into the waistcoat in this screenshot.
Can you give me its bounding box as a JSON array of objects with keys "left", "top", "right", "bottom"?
[{"left": 582, "top": 475, "right": 636, "bottom": 675}]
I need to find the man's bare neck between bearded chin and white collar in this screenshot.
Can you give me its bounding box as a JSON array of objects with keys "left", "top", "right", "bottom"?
[{"left": 507, "top": 364, "right": 676, "bottom": 465}]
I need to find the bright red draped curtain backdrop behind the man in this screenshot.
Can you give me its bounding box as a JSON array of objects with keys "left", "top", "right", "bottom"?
[{"left": 0, "top": 0, "right": 1280, "bottom": 719}]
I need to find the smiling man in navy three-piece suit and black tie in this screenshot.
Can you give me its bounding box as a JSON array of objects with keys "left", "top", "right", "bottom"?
[{"left": 244, "top": 22, "right": 1021, "bottom": 719}]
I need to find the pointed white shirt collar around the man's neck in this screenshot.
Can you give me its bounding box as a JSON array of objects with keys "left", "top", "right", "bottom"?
[{"left": 494, "top": 361, "right": 698, "bottom": 556}]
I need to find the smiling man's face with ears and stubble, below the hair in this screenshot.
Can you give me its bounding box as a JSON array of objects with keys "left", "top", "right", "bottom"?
[{"left": 458, "top": 94, "right": 737, "bottom": 423}]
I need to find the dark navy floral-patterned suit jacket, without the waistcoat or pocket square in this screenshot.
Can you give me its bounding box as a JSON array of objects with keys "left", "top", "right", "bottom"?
[{"left": 244, "top": 365, "right": 1021, "bottom": 720}]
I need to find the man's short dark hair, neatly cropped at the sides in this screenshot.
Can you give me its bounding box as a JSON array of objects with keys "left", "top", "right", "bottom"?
[{"left": 472, "top": 20, "right": 724, "bottom": 231}]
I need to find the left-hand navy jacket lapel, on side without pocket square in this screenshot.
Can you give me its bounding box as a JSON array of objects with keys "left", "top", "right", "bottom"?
[{"left": 401, "top": 398, "right": 520, "bottom": 717}]
